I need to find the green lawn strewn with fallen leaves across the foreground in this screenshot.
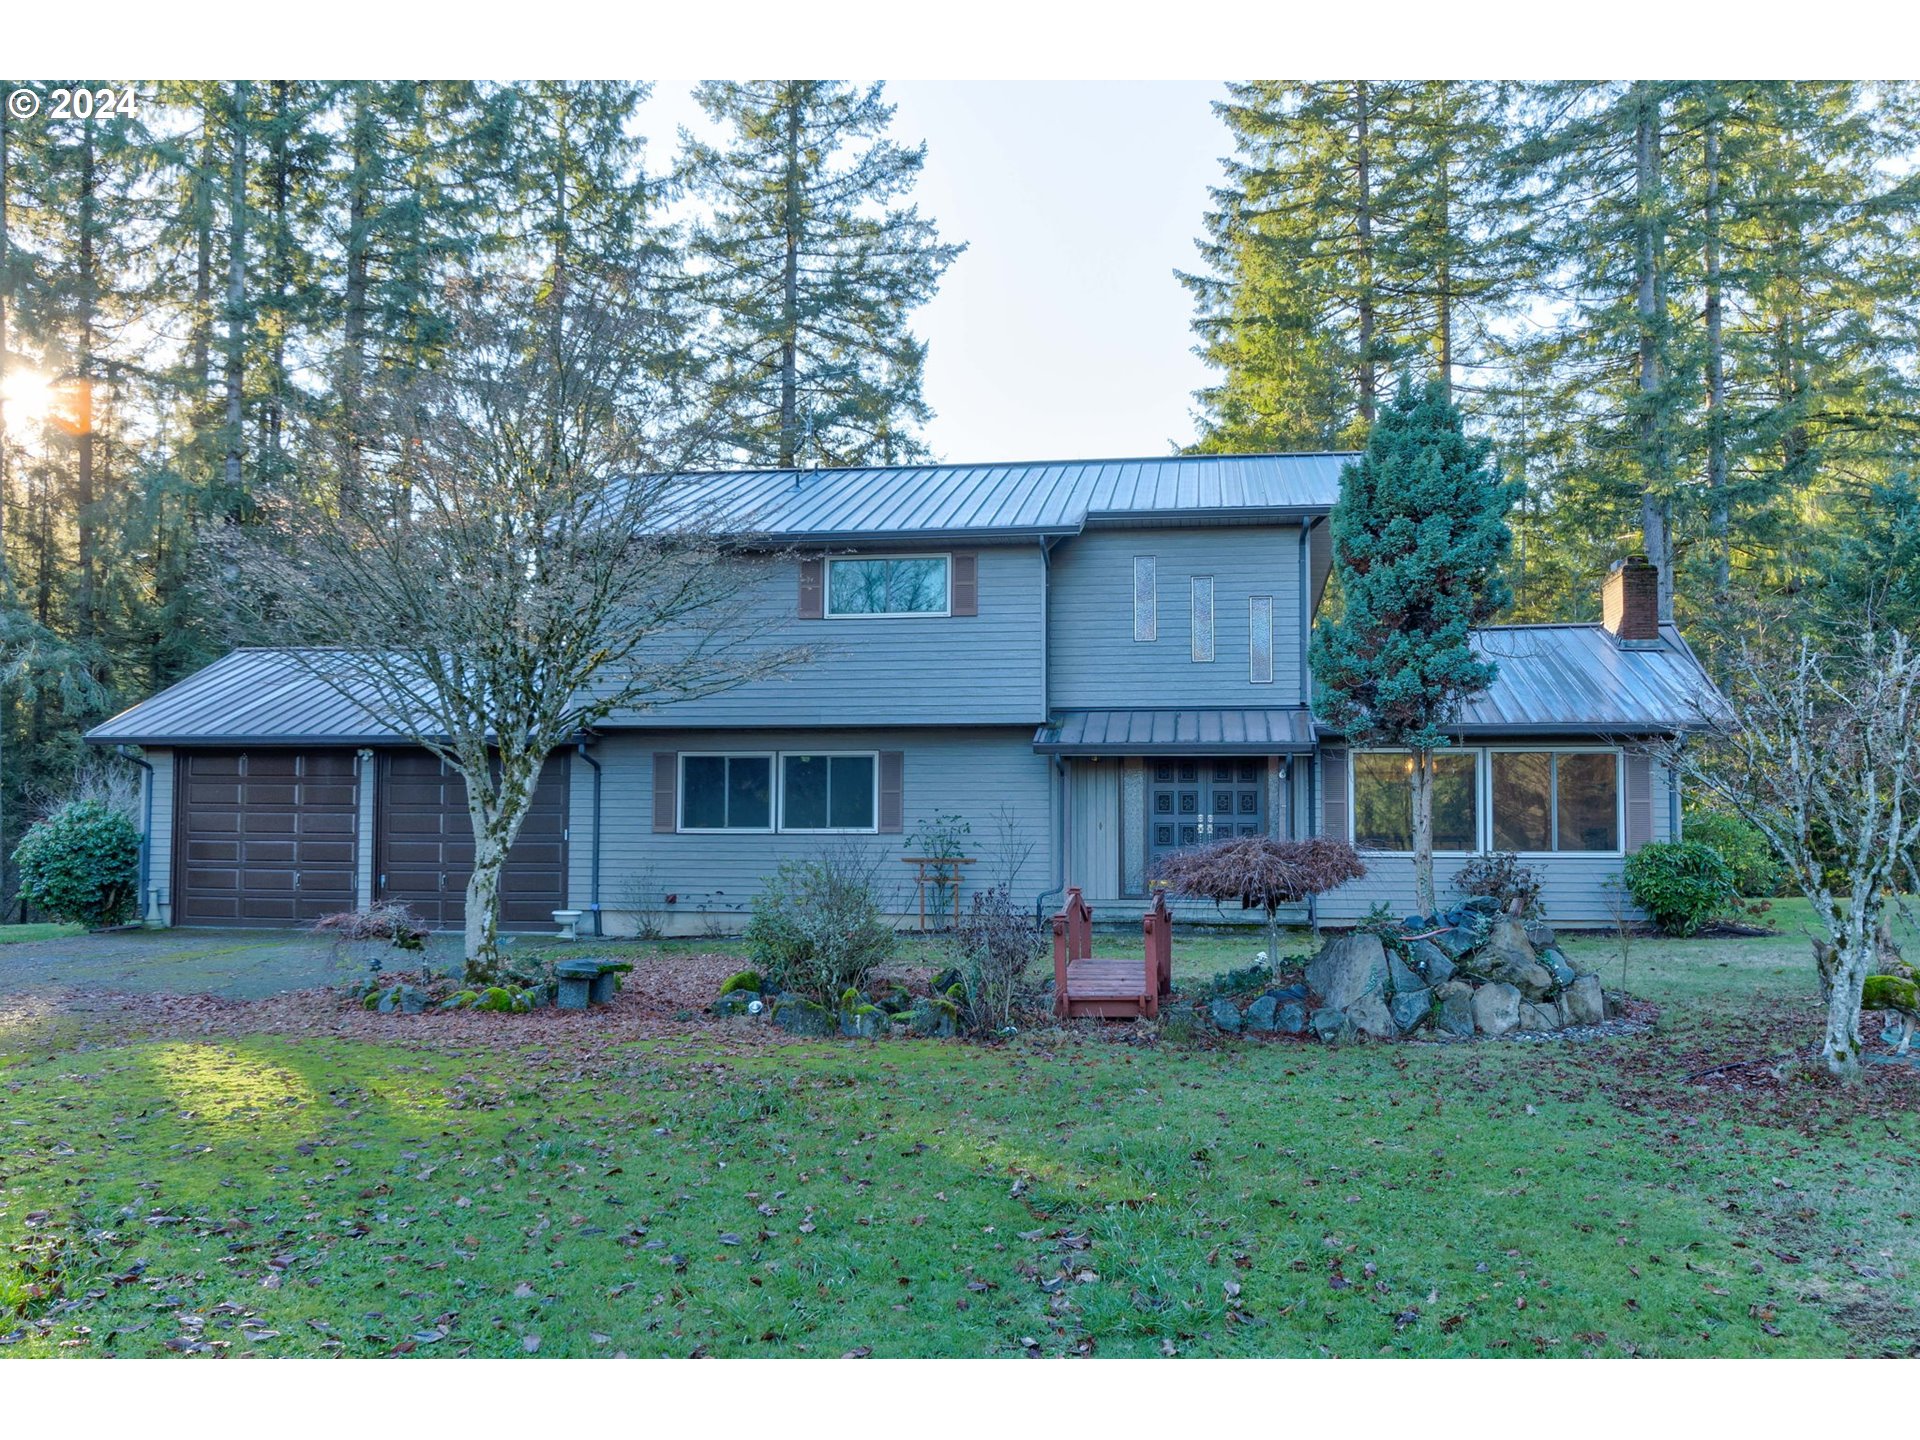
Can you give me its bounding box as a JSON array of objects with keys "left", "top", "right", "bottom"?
[{"left": 0, "top": 910, "right": 1920, "bottom": 1356}]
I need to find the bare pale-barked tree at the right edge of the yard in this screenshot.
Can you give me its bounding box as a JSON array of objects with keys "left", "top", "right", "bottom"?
[{"left": 1667, "top": 630, "right": 1920, "bottom": 1077}]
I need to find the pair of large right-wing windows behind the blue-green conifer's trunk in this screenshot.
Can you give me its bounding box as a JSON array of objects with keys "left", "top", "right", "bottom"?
[{"left": 1352, "top": 747, "right": 1620, "bottom": 854}]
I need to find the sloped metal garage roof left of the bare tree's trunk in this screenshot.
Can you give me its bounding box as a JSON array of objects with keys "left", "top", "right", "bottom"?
[{"left": 86, "top": 649, "right": 403, "bottom": 745}]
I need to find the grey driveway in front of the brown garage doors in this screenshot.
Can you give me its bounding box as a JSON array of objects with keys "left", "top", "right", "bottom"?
[{"left": 0, "top": 929, "right": 461, "bottom": 1000}]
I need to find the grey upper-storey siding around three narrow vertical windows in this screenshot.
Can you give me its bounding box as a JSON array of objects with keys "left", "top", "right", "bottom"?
[{"left": 1046, "top": 526, "right": 1302, "bottom": 710}]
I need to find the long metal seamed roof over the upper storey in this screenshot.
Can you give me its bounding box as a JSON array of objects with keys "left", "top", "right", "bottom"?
[{"left": 648, "top": 453, "right": 1352, "bottom": 541}]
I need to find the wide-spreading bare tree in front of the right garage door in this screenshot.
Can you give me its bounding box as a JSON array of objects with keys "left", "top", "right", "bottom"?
[{"left": 213, "top": 273, "right": 806, "bottom": 981}]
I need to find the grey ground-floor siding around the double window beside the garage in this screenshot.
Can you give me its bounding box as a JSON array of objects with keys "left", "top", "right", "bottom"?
[{"left": 568, "top": 733, "right": 1058, "bottom": 935}]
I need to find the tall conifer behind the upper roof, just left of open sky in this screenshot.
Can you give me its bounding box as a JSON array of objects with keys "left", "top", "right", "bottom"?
[{"left": 680, "top": 81, "right": 964, "bottom": 467}]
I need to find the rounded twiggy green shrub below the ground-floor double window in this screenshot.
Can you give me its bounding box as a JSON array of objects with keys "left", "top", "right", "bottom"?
[{"left": 745, "top": 852, "right": 893, "bottom": 1010}]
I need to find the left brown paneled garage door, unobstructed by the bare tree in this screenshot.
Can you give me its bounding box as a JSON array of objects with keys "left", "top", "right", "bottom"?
[{"left": 173, "top": 751, "right": 359, "bottom": 925}]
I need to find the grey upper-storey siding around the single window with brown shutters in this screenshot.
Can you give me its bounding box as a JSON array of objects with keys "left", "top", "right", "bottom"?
[{"left": 620, "top": 545, "right": 1044, "bottom": 730}]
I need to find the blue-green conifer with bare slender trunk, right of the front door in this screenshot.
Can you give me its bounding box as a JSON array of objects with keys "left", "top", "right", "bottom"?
[{"left": 1309, "top": 378, "right": 1517, "bottom": 914}]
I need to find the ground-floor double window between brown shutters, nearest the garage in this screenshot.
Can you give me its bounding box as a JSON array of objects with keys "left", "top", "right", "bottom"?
[{"left": 678, "top": 751, "right": 879, "bottom": 835}]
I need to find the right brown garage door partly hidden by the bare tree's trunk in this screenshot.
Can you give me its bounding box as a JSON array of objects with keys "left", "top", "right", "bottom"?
[{"left": 374, "top": 751, "right": 566, "bottom": 929}]
